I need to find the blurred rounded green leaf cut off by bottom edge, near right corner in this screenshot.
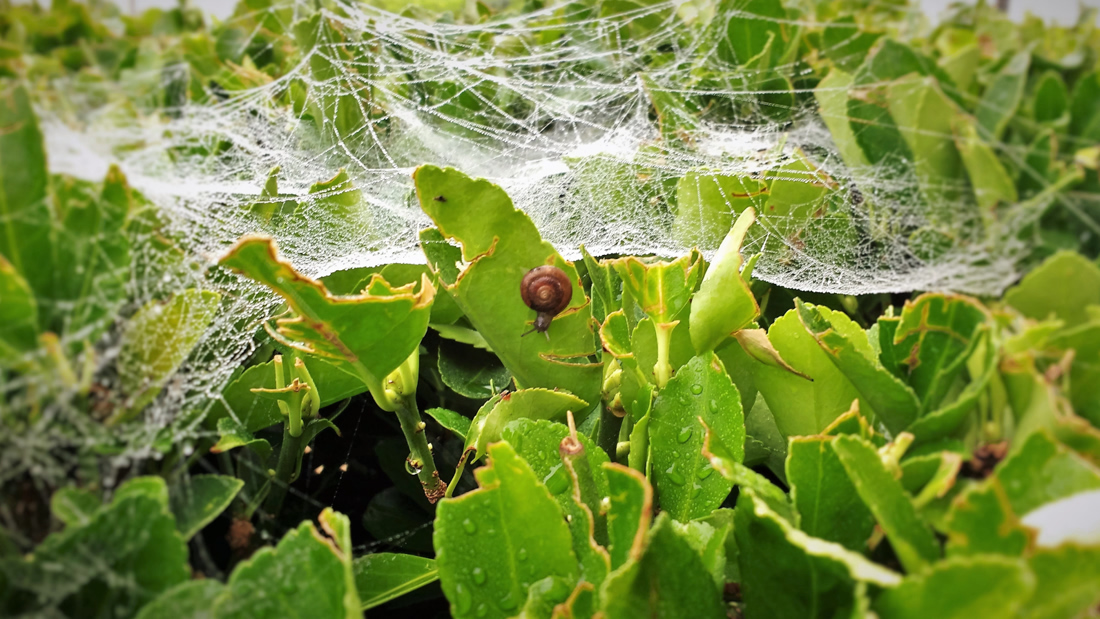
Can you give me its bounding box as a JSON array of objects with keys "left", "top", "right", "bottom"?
[{"left": 875, "top": 556, "right": 1029, "bottom": 619}]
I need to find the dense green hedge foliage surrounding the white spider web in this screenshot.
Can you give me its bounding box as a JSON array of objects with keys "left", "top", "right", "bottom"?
[{"left": 0, "top": 0, "right": 1100, "bottom": 619}]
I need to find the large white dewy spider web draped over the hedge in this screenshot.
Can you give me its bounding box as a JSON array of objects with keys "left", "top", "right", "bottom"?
[{"left": 23, "top": 1, "right": 1073, "bottom": 479}]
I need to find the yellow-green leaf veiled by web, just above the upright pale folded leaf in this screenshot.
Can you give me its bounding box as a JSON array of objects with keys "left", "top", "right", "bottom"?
[{"left": 672, "top": 169, "right": 768, "bottom": 250}]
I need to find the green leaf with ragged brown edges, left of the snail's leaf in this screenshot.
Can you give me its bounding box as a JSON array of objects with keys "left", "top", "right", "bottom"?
[{"left": 220, "top": 236, "right": 435, "bottom": 406}]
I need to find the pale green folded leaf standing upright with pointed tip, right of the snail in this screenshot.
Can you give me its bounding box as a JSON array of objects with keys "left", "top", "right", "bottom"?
[{"left": 689, "top": 207, "right": 760, "bottom": 354}]
